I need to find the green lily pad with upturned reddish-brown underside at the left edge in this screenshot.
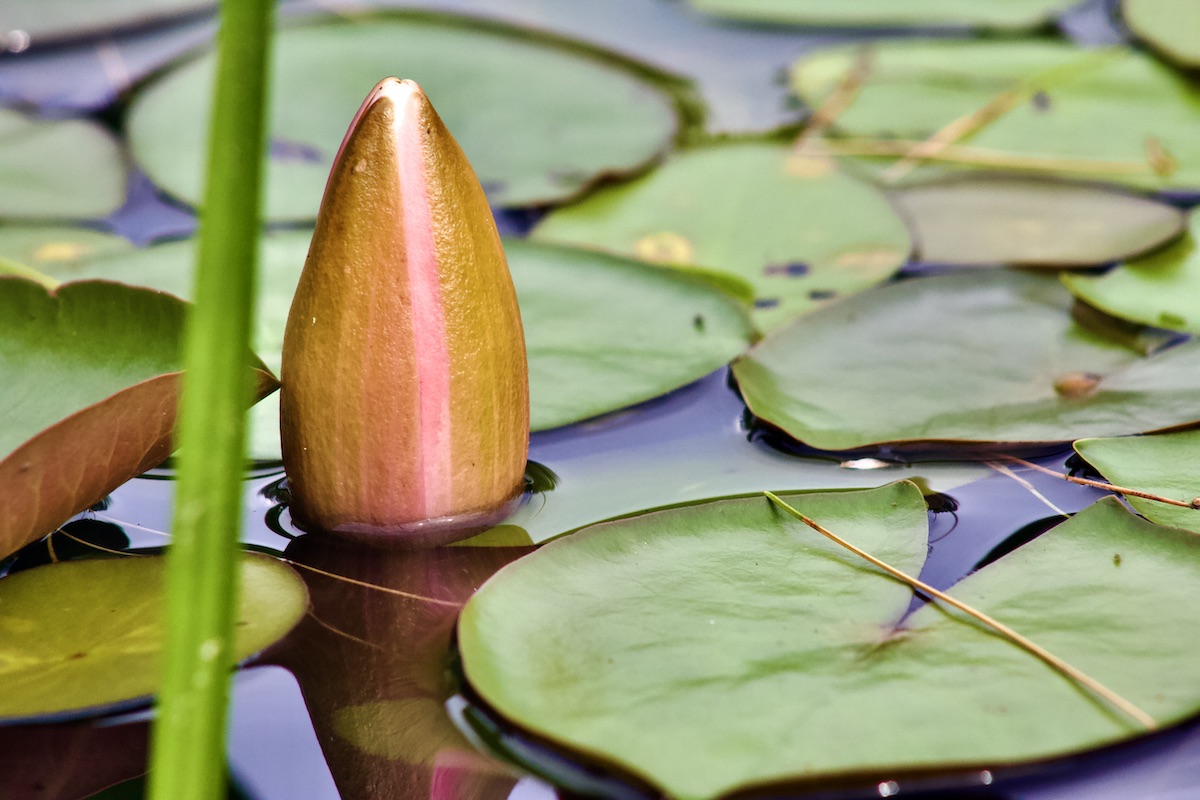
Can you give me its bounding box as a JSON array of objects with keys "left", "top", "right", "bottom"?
[{"left": 0, "top": 278, "right": 275, "bottom": 557}]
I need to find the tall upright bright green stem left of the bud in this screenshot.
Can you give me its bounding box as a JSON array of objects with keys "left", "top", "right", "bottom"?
[{"left": 149, "top": 0, "right": 274, "bottom": 800}]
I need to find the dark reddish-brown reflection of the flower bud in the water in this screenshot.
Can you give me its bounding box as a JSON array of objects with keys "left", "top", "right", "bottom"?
[{"left": 269, "top": 525, "right": 533, "bottom": 800}]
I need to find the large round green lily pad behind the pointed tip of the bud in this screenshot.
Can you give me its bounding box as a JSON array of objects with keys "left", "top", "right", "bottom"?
[{"left": 128, "top": 12, "right": 679, "bottom": 219}]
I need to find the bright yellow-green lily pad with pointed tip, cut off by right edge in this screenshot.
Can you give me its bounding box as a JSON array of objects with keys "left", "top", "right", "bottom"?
[{"left": 1063, "top": 211, "right": 1200, "bottom": 333}]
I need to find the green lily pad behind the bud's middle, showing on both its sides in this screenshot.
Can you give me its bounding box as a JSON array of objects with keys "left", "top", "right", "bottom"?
[{"left": 28, "top": 230, "right": 754, "bottom": 461}]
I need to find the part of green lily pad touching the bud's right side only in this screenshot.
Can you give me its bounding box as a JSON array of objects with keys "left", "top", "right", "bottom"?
[{"left": 505, "top": 240, "right": 752, "bottom": 431}]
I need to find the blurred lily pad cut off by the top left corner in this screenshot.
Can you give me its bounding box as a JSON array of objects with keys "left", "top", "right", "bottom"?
[{"left": 4, "top": 0, "right": 216, "bottom": 44}]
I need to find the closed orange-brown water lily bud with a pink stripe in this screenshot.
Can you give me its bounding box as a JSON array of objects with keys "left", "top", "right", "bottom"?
[{"left": 280, "top": 78, "right": 529, "bottom": 543}]
